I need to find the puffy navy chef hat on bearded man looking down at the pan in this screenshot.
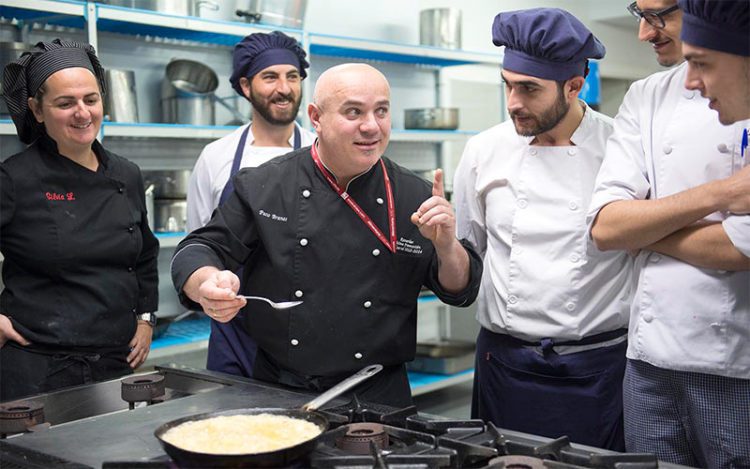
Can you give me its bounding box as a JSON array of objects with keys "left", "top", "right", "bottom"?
[{"left": 492, "top": 8, "right": 606, "bottom": 81}]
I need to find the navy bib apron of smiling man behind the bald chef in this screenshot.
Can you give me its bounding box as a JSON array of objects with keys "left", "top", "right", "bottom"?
[{"left": 206, "top": 124, "right": 302, "bottom": 378}]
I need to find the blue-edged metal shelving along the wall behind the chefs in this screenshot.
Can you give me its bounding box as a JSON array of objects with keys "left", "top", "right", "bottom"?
[{"left": 0, "top": 0, "right": 482, "bottom": 395}]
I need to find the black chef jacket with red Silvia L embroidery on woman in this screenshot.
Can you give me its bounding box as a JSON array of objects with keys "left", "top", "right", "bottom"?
[{"left": 0, "top": 135, "right": 159, "bottom": 350}]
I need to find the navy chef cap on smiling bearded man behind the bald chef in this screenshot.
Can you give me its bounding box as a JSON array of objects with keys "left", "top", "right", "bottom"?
[{"left": 229, "top": 31, "right": 310, "bottom": 96}]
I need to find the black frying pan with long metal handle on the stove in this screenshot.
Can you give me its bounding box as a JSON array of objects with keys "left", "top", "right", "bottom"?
[{"left": 154, "top": 365, "right": 383, "bottom": 467}]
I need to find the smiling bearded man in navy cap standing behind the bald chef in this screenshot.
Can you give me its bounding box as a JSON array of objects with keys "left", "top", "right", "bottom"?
[{"left": 187, "top": 31, "right": 315, "bottom": 377}]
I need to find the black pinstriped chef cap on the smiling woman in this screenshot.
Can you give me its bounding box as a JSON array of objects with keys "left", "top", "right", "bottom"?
[{"left": 3, "top": 39, "right": 107, "bottom": 143}]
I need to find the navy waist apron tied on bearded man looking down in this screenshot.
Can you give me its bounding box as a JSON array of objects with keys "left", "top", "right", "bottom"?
[{"left": 471, "top": 328, "right": 628, "bottom": 451}]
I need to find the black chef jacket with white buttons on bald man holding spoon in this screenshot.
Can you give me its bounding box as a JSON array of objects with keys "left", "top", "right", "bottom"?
[{"left": 172, "top": 147, "right": 482, "bottom": 376}]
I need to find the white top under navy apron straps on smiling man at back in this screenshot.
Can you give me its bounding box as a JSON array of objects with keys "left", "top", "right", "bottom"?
[{"left": 187, "top": 124, "right": 315, "bottom": 232}]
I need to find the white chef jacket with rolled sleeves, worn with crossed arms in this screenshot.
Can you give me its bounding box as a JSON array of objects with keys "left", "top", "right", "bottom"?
[{"left": 587, "top": 64, "right": 750, "bottom": 378}]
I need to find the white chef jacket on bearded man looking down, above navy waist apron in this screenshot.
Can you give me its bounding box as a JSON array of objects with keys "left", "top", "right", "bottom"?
[{"left": 453, "top": 102, "right": 632, "bottom": 341}]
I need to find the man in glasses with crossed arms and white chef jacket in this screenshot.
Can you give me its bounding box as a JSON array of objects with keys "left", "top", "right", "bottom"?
[{"left": 588, "top": 0, "right": 750, "bottom": 468}]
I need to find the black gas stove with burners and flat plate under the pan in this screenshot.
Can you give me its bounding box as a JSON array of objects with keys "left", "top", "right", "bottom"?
[{"left": 0, "top": 365, "right": 685, "bottom": 469}]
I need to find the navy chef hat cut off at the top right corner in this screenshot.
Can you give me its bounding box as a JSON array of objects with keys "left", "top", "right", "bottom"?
[{"left": 678, "top": 0, "right": 750, "bottom": 57}]
